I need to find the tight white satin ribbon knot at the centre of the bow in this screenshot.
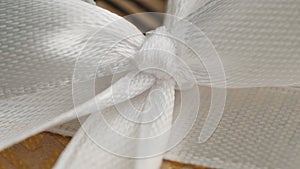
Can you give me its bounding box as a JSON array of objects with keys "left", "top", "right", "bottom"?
[{"left": 135, "top": 26, "right": 192, "bottom": 88}]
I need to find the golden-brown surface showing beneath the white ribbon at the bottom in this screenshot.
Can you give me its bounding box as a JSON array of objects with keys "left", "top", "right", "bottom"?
[{"left": 0, "top": 132, "right": 211, "bottom": 169}]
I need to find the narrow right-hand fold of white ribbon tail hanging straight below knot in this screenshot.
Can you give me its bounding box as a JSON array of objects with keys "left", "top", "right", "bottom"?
[{"left": 135, "top": 81, "right": 175, "bottom": 169}]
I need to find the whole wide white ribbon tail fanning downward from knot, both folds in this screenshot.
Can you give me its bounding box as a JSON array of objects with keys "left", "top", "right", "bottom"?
[{"left": 55, "top": 79, "right": 175, "bottom": 169}]
